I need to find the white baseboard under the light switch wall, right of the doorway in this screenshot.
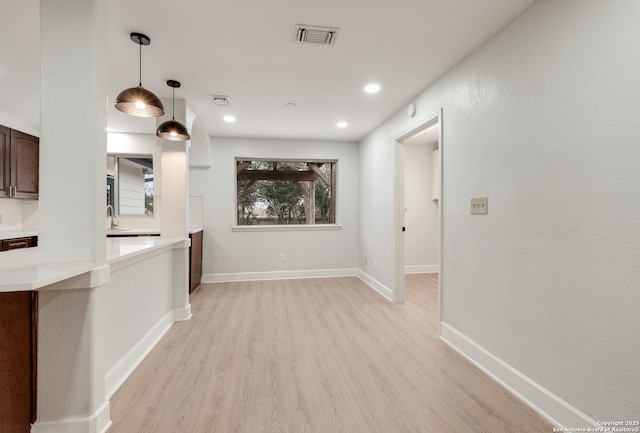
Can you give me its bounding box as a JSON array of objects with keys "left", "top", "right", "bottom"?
[{"left": 440, "top": 323, "right": 598, "bottom": 428}]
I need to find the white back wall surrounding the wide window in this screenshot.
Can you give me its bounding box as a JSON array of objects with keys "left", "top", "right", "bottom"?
[{"left": 189, "top": 138, "right": 358, "bottom": 281}]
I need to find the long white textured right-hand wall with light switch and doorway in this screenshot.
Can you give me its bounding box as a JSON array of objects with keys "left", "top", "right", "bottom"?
[{"left": 360, "top": 0, "right": 640, "bottom": 426}]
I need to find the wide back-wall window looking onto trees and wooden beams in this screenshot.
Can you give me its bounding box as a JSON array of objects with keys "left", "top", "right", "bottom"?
[{"left": 236, "top": 158, "right": 337, "bottom": 226}]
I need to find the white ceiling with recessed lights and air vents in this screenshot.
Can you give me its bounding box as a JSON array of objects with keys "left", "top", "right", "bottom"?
[{"left": 0, "top": 0, "right": 533, "bottom": 140}]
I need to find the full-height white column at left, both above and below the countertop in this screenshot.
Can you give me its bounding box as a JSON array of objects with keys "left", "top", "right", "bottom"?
[{"left": 32, "top": 0, "right": 110, "bottom": 433}]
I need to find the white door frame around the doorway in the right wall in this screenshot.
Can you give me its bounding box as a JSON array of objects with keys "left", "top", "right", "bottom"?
[{"left": 393, "top": 108, "right": 444, "bottom": 333}]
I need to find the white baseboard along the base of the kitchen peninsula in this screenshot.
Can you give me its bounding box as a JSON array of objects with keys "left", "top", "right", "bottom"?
[{"left": 104, "top": 311, "right": 174, "bottom": 399}]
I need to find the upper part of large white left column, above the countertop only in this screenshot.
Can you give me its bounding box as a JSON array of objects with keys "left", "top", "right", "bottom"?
[{"left": 38, "top": 0, "right": 107, "bottom": 264}]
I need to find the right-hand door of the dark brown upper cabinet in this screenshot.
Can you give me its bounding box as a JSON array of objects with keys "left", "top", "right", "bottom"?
[{"left": 10, "top": 130, "right": 40, "bottom": 199}]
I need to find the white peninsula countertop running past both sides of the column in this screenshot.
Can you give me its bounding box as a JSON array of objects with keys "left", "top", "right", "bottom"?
[{"left": 0, "top": 237, "right": 188, "bottom": 292}]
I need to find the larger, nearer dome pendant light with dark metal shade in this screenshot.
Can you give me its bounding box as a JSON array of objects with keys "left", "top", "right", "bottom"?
[{"left": 116, "top": 33, "right": 164, "bottom": 117}]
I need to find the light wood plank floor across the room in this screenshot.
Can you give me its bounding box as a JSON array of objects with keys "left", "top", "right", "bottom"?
[{"left": 111, "top": 274, "right": 552, "bottom": 433}]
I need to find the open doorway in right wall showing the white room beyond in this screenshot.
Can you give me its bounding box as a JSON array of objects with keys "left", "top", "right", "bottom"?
[{"left": 394, "top": 109, "right": 443, "bottom": 330}]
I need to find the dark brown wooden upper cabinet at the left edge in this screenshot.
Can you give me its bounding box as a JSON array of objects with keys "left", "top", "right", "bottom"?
[{"left": 0, "top": 125, "right": 40, "bottom": 200}]
